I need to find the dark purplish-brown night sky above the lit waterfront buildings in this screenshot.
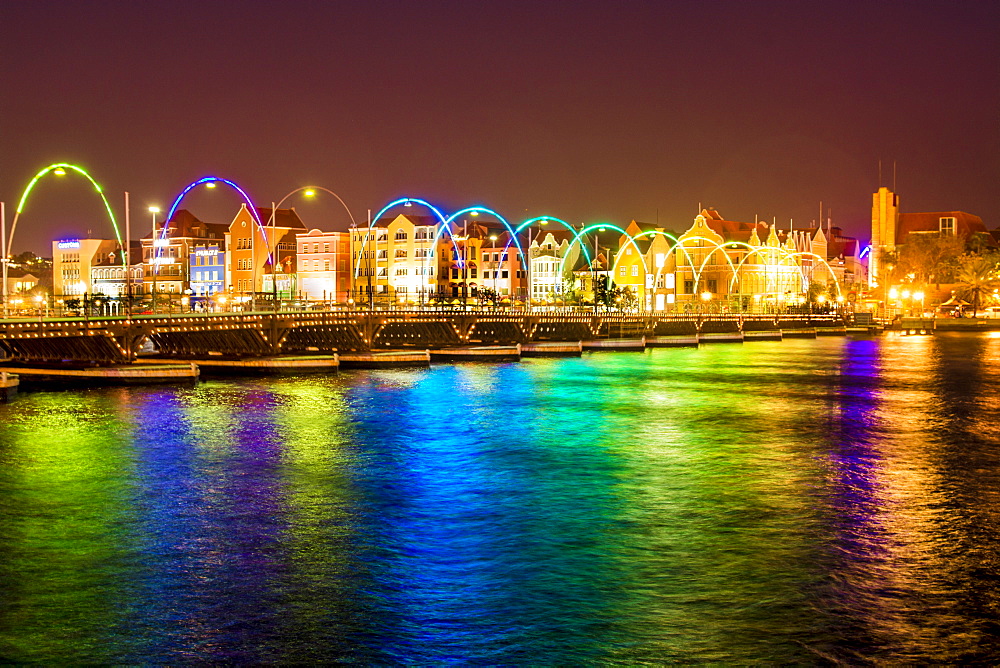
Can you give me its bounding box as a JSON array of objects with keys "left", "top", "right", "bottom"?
[{"left": 0, "top": 0, "right": 1000, "bottom": 255}]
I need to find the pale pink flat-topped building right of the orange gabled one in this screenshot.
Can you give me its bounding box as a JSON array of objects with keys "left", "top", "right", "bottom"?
[{"left": 295, "top": 229, "right": 351, "bottom": 303}]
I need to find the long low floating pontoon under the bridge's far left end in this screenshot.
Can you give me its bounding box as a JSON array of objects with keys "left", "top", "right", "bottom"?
[{"left": 0, "top": 362, "right": 200, "bottom": 387}]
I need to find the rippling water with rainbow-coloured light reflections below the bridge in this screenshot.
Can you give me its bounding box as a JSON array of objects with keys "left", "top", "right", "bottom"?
[{"left": 0, "top": 334, "right": 1000, "bottom": 665}]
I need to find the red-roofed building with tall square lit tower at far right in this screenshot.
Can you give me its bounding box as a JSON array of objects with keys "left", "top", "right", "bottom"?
[{"left": 868, "top": 186, "right": 996, "bottom": 287}]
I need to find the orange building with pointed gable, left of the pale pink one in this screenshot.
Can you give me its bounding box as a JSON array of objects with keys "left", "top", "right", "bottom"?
[{"left": 223, "top": 204, "right": 306, "bottom": 299}]
